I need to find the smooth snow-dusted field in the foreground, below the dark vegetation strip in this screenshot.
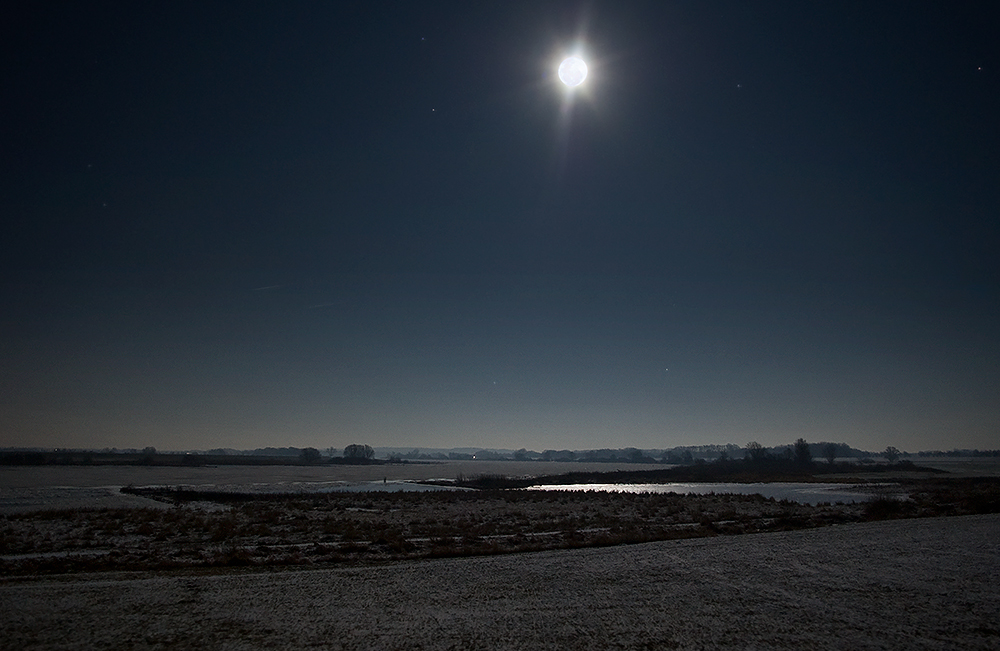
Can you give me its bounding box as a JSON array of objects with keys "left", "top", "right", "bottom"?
[{"left": 0, "top": 515, "right": 1000, "bottom": 650}]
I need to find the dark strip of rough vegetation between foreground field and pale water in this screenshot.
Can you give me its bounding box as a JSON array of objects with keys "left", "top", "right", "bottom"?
[{"left": 0, "top": 479, "right": 1000, "bottom": 576}]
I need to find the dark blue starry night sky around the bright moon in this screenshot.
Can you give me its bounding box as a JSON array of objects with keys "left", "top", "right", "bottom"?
[{"left": 0, "top": 1, "right": 1000, "bottom": 451}]
